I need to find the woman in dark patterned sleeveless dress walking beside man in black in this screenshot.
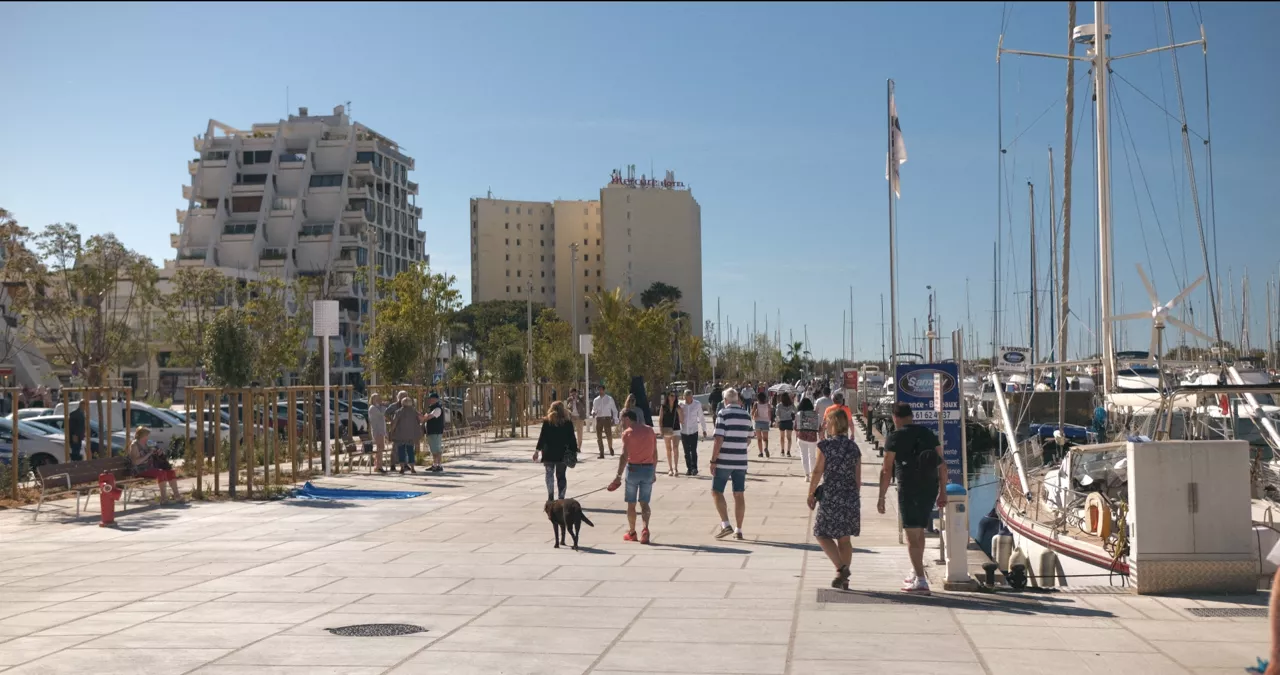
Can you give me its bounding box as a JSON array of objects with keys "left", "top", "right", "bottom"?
[{"left": 809, "top": 409, "right": 863, "bottom": 590}]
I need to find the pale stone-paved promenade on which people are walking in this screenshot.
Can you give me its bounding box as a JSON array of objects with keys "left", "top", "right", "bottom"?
[{"left": 0, "top": 422, "right": 1267, "bottom": 675}]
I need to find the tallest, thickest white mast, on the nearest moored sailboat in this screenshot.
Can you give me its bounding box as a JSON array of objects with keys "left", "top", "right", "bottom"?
[{"left": 1093, "top": 0, "right": 1116, "bottom": 393}]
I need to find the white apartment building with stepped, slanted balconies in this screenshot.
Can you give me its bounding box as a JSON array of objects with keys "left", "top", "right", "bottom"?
[{"left": 165, "top": 105, "right": 429, "bottom": 382}]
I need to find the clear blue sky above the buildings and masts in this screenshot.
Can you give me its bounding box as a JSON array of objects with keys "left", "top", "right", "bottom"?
[{"left": 0, "top": 3, "right": 1280, "bottom": 357}]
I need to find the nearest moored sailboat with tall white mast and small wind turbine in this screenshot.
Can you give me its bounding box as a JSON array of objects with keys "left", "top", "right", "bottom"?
[{"left": 991, "top": 1, "right": 1264, "bottom": 590}]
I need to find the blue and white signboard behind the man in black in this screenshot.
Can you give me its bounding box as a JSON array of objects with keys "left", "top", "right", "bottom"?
[{"left": 896, "top": 362, "right": 965, "bottom": 485}]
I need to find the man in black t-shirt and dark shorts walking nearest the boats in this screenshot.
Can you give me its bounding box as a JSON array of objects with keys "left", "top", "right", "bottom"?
[{"left": 876, "top": 403, "right": 947, "bottom": 596}]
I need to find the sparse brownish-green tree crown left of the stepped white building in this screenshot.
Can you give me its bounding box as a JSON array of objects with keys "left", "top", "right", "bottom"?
[{"left": 8, "top": 223, "right": 159, "bottom": 386}]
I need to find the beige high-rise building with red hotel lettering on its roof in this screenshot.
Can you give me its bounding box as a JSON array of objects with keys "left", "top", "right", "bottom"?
[{"left": 471, "top": 168, "right": 703, "bottom": 333}]
